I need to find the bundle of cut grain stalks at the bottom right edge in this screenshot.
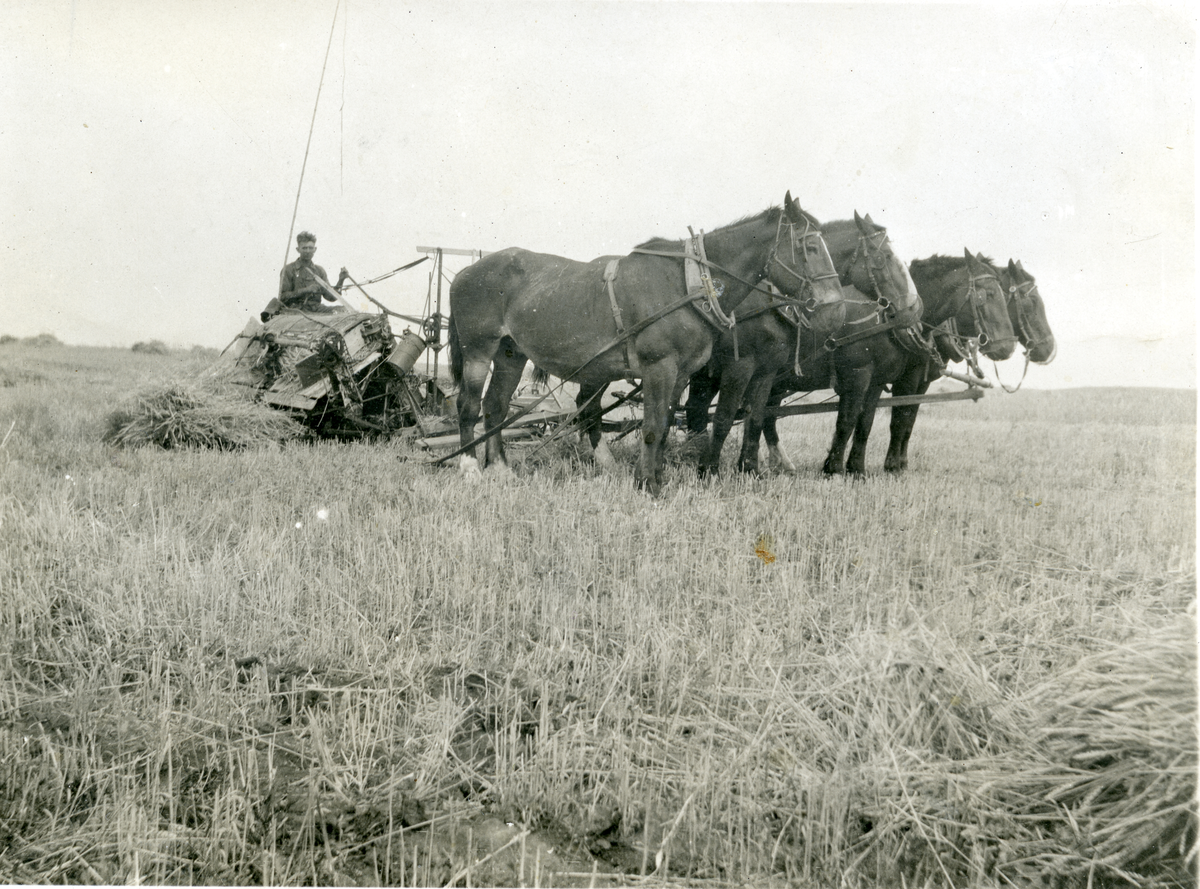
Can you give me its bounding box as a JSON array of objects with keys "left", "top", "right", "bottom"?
[{"left": 1033, "top": 615, "right": 1198, "bottom": 884}]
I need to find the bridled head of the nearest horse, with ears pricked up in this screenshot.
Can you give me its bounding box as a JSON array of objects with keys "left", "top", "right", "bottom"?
[{"left": 767, "top": 191, "right": 846, "bottom": 336}]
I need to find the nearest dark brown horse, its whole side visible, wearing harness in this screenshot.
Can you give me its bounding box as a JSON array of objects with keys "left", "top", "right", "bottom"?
[{"left": 450, "top": 193, "right": 841, "bottom": 494}]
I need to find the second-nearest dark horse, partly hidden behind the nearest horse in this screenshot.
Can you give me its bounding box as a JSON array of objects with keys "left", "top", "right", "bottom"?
[{"left": 688, "top": 212, "right": 920, "bottom": 474}]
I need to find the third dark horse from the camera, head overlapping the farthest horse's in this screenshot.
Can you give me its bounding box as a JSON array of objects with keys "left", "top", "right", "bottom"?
[{"left": 689, "top": 251, "right": 1015, "bottom": 475}]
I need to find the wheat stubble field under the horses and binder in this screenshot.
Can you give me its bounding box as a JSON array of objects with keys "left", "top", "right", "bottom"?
[{"left": 0, "top": 342, "right": 1196, "bottom": 887}]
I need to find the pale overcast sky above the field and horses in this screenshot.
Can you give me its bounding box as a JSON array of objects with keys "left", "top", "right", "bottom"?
[{"left": 0, "top": 0, "right": 1196, "bottom": 388}]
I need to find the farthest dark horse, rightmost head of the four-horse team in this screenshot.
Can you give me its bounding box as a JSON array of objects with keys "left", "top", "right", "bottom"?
[{"left": 883, "top": 259, "right": 1058, "bottom": 473}]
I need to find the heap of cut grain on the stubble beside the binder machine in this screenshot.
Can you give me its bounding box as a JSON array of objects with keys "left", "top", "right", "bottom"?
[{"left": 104, "top": 383, "right": 306, "bottom": 450}]
